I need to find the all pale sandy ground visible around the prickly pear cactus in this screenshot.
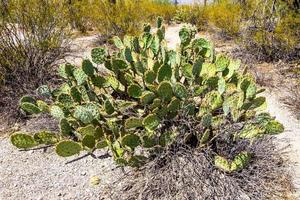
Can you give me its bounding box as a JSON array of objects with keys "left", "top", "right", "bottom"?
[{"left": 0, "top": 25, "right": 300, "bottom": 200}]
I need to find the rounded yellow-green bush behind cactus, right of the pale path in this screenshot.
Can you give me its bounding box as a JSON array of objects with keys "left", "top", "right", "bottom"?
[{"left": 206, "top": 0, "right": 241, "bottom": 36}]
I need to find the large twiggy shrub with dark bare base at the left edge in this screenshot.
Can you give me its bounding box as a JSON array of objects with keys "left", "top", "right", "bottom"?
[{"left": 0, "top": 0, "right": 68, "bottom": 90}]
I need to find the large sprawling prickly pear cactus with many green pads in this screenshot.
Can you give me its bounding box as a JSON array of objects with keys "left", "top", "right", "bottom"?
[{"left": 11, "top": 18, "right": 283, "bottom": 172}]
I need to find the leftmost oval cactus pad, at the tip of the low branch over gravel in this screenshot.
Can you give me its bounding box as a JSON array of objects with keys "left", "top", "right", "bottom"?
[{"left": 10, "top": 132, "right": 38, "bottom": 149}]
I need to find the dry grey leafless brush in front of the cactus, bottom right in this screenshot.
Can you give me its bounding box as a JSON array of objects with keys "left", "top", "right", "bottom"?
[{"left": 106, "top": 138, "right": 292, "bottom": 200}]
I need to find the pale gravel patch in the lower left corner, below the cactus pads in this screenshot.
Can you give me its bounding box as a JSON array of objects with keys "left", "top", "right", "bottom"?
[{"left": 0, "top": 138, "right": 122, "bottom": 200}]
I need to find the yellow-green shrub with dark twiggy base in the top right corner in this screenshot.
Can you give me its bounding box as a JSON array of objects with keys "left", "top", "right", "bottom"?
[{"left": 243, "top": 1, "right": 300, "bottom": 60}]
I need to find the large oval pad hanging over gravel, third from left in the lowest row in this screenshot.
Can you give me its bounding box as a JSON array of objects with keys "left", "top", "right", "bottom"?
[{"left": 55, "top": 140, "right": 82, "bottom": 157}]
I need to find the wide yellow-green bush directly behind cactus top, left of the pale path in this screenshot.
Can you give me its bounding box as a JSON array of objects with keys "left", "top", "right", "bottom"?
[{"left": 93, "top": 0, "right": 176, "bottom": 36}]
